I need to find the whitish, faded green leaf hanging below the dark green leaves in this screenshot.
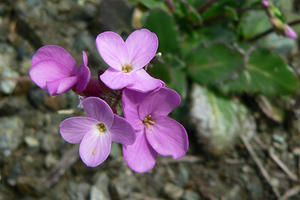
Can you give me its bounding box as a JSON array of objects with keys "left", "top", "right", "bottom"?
[{"left": 190, "top": 84, "right": 256, "bottom": 154}]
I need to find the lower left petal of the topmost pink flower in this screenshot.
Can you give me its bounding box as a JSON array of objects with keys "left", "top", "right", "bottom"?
[{"left": 100, "top": 68, "right": 133, "bottom": 90}]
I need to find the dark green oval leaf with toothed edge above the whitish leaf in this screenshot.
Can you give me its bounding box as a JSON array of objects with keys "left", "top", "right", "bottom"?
[{"left": 185, "top": 44, "right": 243, "bottom": 85}]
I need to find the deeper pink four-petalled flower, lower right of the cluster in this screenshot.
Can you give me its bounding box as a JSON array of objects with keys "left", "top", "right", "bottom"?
[{"left": 122, "top": 88, "right": 189, "bottom": 173}]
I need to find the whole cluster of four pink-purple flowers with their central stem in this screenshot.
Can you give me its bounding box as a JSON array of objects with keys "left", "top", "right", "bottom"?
[{"left": 30, "top": 29, "right": 189, "bottom": 173}]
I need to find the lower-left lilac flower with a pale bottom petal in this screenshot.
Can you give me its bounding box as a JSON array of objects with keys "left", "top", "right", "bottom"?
[{"left": 60, "top": 97, "right": 135, "bottom": 167}]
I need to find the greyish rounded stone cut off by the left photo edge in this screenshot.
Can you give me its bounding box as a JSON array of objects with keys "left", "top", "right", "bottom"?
[{"left": 0, "top": 117, "right": 24, "bottom": 157}]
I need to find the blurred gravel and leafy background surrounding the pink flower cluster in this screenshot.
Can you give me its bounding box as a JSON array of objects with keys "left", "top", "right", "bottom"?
[{"left": 0, "top": 0, "right": 300, "bottom": 200}]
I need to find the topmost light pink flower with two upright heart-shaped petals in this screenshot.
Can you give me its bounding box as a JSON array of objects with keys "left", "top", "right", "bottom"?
[{"left": 96, "top": 29, "right": 162, "bottom": 92}]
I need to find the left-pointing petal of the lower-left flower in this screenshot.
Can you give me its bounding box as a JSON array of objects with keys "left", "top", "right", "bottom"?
[{"left": 59, "top": 117, "right": 97, "bottom": 144}]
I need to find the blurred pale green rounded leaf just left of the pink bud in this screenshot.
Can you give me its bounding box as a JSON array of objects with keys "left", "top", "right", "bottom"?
[{"left": 239, "top": 10, "right": 272, "bottom": 39}]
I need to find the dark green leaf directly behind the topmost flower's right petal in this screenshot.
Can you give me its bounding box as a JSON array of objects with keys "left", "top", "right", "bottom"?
[{"left": 145, "top": 10, "right": 180, "bottom": 55}]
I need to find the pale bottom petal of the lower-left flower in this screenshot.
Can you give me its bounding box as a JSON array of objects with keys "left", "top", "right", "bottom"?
[{"left": 79, "top": 129, "right": 111, "bottom": 167}]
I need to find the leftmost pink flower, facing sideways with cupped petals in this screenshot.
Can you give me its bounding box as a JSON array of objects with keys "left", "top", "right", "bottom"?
[{"left": 29, "top": 45, "right": 91, "bottom": 95}]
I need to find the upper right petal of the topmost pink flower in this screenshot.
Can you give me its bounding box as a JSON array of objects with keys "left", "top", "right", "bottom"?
[{"left": 125, "top": 29, "right": 158, "bottom": 70}]
